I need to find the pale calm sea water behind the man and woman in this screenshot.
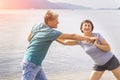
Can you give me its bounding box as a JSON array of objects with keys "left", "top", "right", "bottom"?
[{"left": 0, "top": 9, "right": 120, "bottom": 80}]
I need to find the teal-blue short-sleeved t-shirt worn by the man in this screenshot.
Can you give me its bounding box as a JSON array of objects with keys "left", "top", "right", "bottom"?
[{"left": 25, "top": 23, "right": 62, "bottom": 65}]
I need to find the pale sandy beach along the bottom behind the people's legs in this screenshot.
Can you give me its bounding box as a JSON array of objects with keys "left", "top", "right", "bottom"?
[{"left": 2, "top": 71, "right": 117, "bottom": 80}]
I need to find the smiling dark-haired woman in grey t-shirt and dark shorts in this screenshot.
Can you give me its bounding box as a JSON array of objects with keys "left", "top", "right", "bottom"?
[{"left": 58, "top": 20, "right": 120, "bottom": 80}]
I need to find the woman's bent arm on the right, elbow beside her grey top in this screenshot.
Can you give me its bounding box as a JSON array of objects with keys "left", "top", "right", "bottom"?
[{"left": 94, "top": 39, "right": 111, "bottom": 52}]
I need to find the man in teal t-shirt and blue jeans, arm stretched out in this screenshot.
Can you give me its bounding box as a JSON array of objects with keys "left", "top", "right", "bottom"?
[{"left": 22, "top": 10, "right": 90, "bottom": 80}]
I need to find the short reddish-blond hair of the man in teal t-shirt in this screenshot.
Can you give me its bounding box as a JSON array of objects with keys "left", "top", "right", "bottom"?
[{"left": 44, "top": 10, "right": 58, "bottom": 24}]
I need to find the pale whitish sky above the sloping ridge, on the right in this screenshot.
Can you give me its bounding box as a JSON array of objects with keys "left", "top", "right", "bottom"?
[{"left": 48, "top": 0, "right": 120, "bottom": 8}]
